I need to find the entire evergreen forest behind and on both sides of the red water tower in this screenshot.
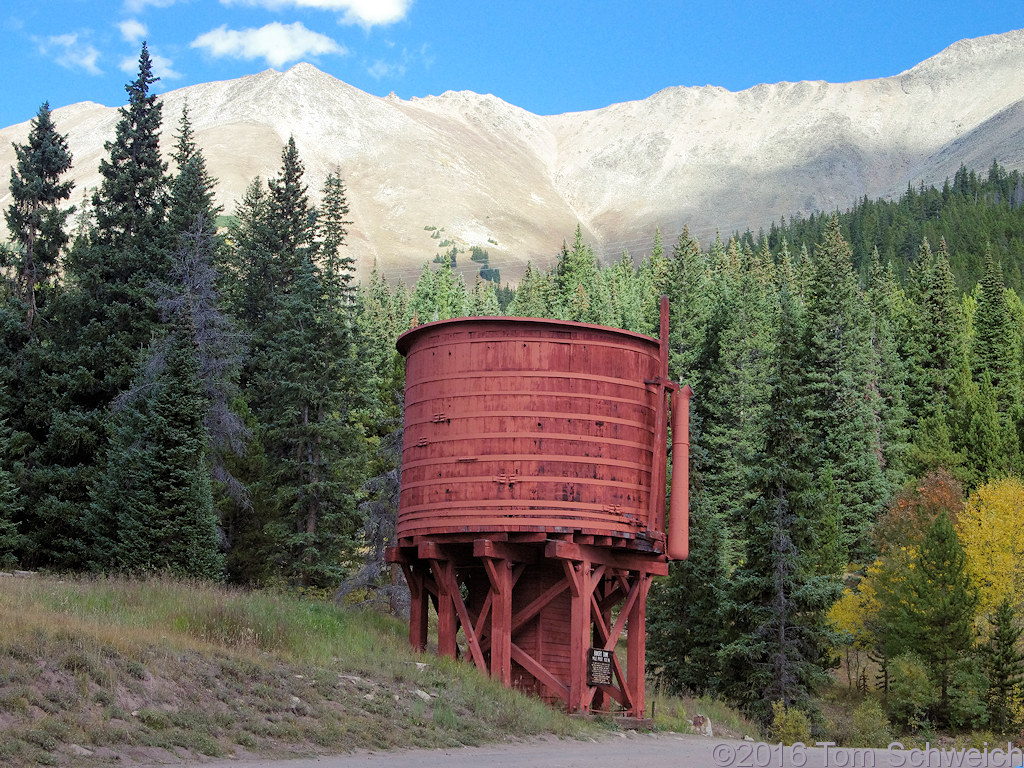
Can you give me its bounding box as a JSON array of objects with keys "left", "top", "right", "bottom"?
[{"left": 6, "top": 45, "right": 1024, "bottom": 733}]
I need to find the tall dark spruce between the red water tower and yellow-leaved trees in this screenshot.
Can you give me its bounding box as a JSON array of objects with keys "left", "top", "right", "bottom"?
[{"left": 722, "top": 274, "right": 842, "bottom": 722}]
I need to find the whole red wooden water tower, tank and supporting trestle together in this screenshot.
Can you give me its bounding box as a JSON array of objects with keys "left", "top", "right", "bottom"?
[{"left": 388, "top": 302, "right": 689, "bottom": 718}]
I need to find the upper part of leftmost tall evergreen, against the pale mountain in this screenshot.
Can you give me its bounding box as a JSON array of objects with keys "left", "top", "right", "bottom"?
[{"left": 4, "top": 101, "right": 75, "bottom": 330}]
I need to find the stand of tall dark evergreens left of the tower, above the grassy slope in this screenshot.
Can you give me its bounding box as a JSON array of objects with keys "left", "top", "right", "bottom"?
[{"left": 0, "top": 45, "right": 374, "bottom": 588}]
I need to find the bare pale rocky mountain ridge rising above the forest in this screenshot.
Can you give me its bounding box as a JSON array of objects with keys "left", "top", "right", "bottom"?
[{"left": 0, "top": 30, "right": 1024, "bottom": 280}]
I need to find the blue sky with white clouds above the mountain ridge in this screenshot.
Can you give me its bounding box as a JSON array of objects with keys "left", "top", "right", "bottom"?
[{"left": 0, "top": 0, "right": 1024, "bottom": 126}]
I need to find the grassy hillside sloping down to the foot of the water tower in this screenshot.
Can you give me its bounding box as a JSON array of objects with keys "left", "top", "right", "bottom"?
[{"left": 0, "top": 577, "right": 599, "bottom": 768}]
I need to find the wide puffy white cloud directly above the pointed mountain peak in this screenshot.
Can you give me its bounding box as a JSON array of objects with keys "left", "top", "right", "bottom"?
[{"left": 191, "top": 22, "right": 348, "bottom": 67}]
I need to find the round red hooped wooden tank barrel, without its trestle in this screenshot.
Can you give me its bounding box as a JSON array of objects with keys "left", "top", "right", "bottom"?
[{"left": 397, "top": 317, "right": 665, "bottom": 549}]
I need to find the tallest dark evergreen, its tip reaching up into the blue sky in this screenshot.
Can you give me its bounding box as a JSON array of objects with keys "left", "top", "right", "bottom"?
[{"left": 24, "top": 45, "right": 170, "bottom": 567}]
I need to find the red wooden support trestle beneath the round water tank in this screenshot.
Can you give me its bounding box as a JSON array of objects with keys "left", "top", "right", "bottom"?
[{"left": 388, "top": 537, "right": 668, "bottom": 719}]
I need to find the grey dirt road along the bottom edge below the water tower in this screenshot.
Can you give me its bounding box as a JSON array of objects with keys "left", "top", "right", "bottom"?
[{"left": 167, "top": 731, "right": 950, "bottom": 768}]
